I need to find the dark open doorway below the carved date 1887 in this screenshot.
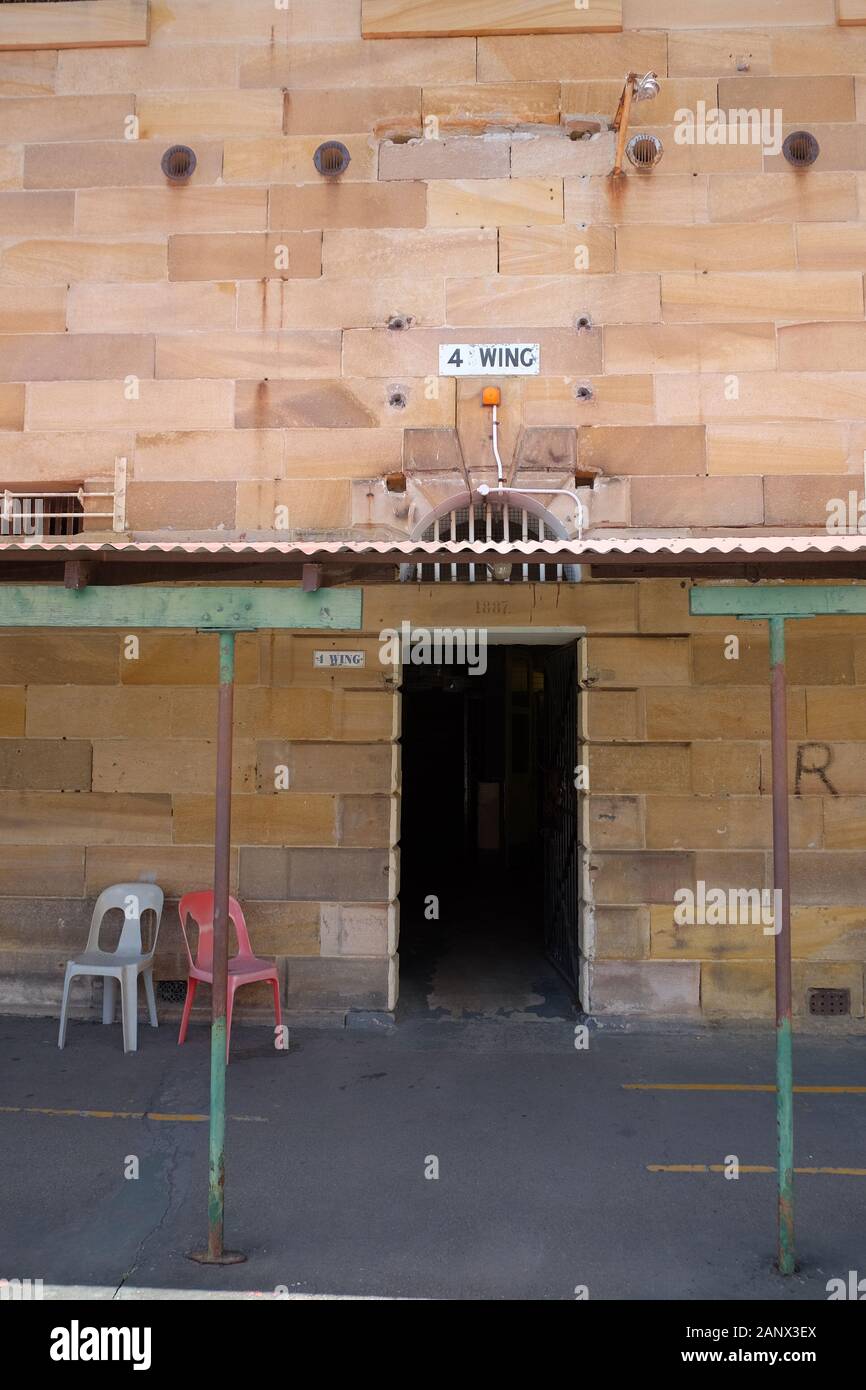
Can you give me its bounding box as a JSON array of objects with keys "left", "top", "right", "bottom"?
[{"left": 399, "top": 642, "right": 578, "bottom": 1019}]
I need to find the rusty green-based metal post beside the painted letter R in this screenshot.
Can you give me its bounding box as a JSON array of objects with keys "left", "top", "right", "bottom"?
[{"left": 769, "top": 617, "right": 794, "bottom": 1275}]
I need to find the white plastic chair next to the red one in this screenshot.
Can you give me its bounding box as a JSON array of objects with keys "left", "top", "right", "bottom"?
[{"left": 57, "top": 883, "right": 164, "bottom": 1052}]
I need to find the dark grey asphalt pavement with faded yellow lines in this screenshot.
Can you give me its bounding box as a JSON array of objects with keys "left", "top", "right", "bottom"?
[{"left": 0, "top": 1016, "right": 866, "bottom": 1300}]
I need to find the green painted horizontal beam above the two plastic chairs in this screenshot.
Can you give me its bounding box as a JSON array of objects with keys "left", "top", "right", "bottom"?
[{"left": 0, "top": 584, "right": 361, "bottom": 632}]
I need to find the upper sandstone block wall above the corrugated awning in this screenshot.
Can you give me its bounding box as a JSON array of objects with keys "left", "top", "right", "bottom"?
[{"left": 0, "top": 0, "right": 866, "bottom": 535}]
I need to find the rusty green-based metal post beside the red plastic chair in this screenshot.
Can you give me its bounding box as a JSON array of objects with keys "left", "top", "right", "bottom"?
[{"left": 190, "top": 632, "right": 246, "bottom": 1265}]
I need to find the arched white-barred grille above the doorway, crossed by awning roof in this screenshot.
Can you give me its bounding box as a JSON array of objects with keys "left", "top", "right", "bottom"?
[{"left": 414, "top": 502, "right": 563, "bottom": 584}]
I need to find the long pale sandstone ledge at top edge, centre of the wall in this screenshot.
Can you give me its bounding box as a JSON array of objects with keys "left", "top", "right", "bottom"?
[{"left": 361, "top": 0, "right": 623, "bottom": 39}]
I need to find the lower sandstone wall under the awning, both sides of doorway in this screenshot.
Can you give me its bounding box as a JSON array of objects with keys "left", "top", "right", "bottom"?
[{"left": 0, "top": 580, "right": 866, "bottom": 1029}]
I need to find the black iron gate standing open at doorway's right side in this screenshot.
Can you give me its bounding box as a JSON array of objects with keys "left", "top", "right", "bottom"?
[{"left": 542, "top": 642, "right": 580, "bottom": 999}]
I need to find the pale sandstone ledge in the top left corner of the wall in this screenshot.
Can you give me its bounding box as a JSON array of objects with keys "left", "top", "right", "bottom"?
[{"left": 0, "top": 0, "right": 149, "bottom": 49}]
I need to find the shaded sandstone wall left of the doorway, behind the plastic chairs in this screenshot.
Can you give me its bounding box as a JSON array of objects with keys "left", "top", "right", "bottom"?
[{"left": 0, "top": 614, "right": 396, "bottom": 1009}]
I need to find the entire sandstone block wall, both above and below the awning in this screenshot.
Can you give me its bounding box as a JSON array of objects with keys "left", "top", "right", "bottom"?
[{"left": 0, "top": 0, "right": 866, "bottom": 1026}]
